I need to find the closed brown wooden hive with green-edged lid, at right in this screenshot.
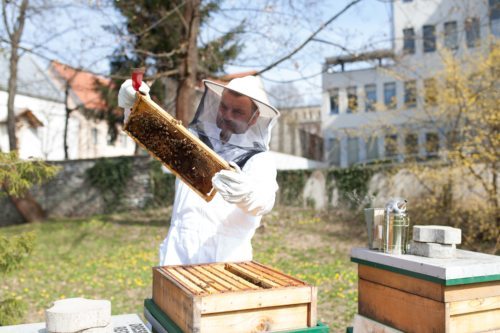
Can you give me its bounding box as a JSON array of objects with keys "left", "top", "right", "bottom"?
[{"left": 351, "top": 249, "right": 500, "bottom": 333}]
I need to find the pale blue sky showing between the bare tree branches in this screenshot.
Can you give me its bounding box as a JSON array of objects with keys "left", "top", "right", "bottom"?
[{"left": 4, "top": 0, "right": 391, "bottom": 105}]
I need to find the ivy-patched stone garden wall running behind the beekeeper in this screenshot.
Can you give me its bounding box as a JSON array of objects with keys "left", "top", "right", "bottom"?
[{"left": 0, "top": 156, "right": 492, "bottom": 225}]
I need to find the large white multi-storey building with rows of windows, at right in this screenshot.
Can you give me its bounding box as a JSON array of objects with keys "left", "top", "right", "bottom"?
[{"left": 321, "top": 0, "right": 500, "bottom": 167}]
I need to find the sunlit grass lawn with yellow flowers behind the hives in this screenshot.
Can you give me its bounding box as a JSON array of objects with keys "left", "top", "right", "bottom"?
[{"left": 0, "top": 207, "right": 365, "bottom": 332}]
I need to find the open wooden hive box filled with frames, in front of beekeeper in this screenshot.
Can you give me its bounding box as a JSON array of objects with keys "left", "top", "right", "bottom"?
[{"left": 153, "top": 261, "right": 317, "bottom": 333}]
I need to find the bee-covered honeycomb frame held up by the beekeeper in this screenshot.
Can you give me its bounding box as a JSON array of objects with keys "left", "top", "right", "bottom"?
[{"left": 124, "top": 93, "right": 230, "bottom": 201}]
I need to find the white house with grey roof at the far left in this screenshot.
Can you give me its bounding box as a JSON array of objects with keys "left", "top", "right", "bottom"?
[{"left": 0, "top": 51, "right": 78, "bottom": 160}]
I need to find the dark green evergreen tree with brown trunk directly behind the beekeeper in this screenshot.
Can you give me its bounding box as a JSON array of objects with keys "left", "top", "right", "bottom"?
[{"left": 105, "top": 0, "right": 243, "bottom": 125}]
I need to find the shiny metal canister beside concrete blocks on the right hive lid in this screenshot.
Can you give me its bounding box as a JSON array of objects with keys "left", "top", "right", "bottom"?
[{"left": 383, "top": 198, "right": 410, "bottom": 254}]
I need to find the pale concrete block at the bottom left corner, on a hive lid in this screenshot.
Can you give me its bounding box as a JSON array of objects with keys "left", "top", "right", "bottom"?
[{"left": 45, "top": 298, "right": 111, "bottom": 333}]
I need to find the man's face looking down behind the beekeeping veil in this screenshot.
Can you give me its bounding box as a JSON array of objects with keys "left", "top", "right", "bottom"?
[{"left": 216, "top": 90, "right": 259, "bottom": 141}]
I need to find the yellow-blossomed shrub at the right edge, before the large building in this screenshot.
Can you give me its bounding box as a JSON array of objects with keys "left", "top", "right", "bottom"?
[{"left": 435, "top": 43, "right": 500, "bottom": 245}]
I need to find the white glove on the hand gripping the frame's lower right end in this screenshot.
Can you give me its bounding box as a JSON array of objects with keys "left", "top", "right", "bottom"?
[{"left": 212, "top": 162, "right": 269, "bottom": 215}]
